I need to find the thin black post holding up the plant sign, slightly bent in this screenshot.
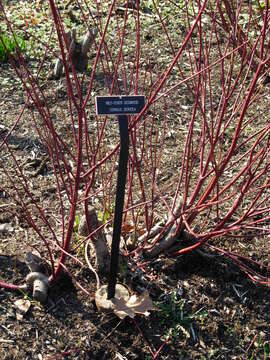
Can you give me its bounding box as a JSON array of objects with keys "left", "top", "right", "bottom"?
[{"left": 107, "top": 115, "right": 129, "bottom": 299}]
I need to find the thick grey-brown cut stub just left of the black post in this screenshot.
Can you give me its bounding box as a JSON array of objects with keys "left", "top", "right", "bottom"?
[{"left": 78, "top": 207, "right": 110, "bottom": 273}]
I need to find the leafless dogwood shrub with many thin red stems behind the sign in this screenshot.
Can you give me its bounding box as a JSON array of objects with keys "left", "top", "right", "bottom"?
[{"left": 0, "top": 0, "right": 270, "bottom": 298}]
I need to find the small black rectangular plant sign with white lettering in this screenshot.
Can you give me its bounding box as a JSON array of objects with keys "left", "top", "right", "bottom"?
[{"left": 95, "top": 95, "right": 145, "bottom": 115}]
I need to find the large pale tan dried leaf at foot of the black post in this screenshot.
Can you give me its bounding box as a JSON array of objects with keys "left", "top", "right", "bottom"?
[{"left": 112, "top": 291, "right": 155, "bottom": 319}]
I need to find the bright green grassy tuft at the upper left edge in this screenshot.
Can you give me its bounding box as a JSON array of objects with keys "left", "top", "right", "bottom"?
[{"left": 0, "top": 34, "right": 26, "bottom": 62}]
